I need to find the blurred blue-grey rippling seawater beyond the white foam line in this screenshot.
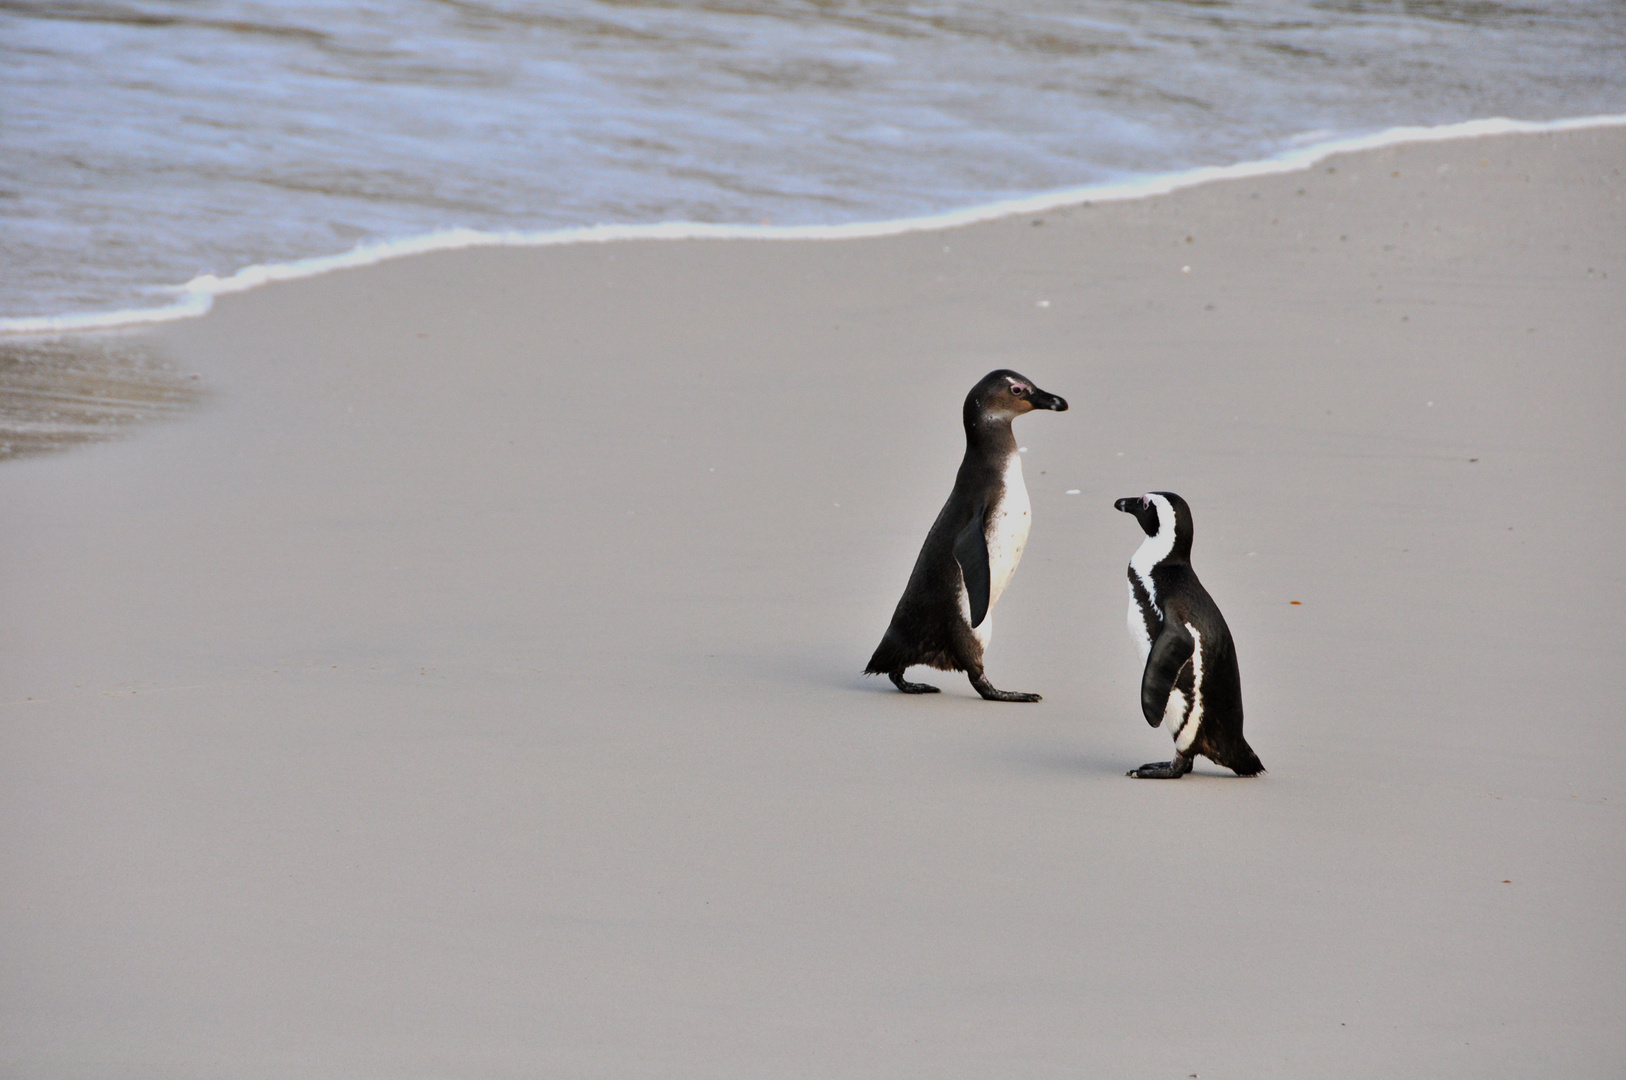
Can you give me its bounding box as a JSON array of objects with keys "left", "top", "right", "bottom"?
[{"left": 0, "top": 0, "right": 1626, "bottom": 325}]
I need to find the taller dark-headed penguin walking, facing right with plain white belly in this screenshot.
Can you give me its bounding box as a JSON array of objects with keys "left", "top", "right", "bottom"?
[{"left": 863, "top": 371, "right": 1067, "bottom": 701}]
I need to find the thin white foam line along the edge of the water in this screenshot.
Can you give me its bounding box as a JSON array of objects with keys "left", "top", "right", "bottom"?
[{"left": 0, "top": 115, "right": 1626, "bottom": 333}]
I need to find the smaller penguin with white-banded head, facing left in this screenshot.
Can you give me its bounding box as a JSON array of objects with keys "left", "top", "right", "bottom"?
[{"left": 1114, "top": 491, "right": 1265, "bottom": 779}]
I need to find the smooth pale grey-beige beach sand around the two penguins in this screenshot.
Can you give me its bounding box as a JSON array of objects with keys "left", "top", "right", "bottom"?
[{"left": 0, "top": 128, "right": 1626, "bottom": 1080}]
